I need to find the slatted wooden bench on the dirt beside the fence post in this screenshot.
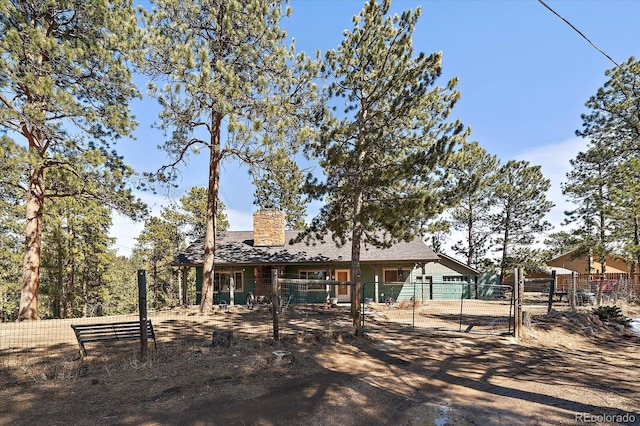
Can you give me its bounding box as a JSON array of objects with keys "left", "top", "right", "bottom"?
[{"left": 71, "top": 320, "right": 158, "bottom": 356}]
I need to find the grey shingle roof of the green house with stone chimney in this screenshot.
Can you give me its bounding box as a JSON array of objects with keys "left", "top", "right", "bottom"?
[{"left": 172, "top": 231, "right": 439, "bottom": 266}]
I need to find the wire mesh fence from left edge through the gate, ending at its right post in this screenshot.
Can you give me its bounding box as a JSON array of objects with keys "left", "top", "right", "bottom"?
[{"left": 0, "top": 279, "right": 524, "bottom": 368}]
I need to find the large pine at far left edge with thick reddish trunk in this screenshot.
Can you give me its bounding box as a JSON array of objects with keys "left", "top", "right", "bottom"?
[{"left": 0, "top": 0, "right": 142, "bottom": 320}]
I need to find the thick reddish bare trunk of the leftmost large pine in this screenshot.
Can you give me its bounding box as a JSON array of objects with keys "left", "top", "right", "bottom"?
[{"left": 18, "top": 167, "right": 44, "bottom": 321}]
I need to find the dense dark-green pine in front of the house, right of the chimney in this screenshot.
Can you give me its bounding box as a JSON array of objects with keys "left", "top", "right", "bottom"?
[{"left": 307, "top": 0, "right": 466, "bottom": 333}]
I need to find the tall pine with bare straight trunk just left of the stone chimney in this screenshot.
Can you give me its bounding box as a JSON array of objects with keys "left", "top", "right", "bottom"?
[{"left": 142, "top": 0, "right": 317, "bottom": 311}]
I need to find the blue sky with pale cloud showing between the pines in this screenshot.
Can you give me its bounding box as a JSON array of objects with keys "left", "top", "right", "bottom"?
[{"left": 112, "top": 0, "right": 640, "bottom": 255}]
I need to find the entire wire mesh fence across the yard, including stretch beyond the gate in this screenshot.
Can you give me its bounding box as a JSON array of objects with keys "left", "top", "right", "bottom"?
[{"left": 6, "top": 276, "right": 638, "bottom": 363}]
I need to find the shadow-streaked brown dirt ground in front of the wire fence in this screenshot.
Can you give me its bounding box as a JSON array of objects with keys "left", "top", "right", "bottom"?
[{"left": 0, "top": 308, "right": 640, "bottom": 426}]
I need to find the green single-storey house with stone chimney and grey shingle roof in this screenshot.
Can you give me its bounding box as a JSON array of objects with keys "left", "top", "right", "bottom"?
[{"left": 172, "top": 210, "right": 477, "bottom": 304}]
